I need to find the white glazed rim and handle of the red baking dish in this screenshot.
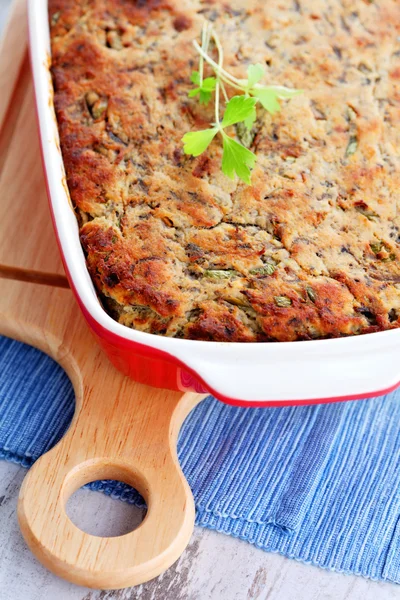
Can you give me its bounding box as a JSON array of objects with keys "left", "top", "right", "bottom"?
[{"left": 28, "top": 0, "right": 400, "bottom": 403}]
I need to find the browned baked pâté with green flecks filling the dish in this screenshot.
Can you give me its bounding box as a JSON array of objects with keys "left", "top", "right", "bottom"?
[{"left": 49, "top": 0, "right": 400, "bottom": 342}]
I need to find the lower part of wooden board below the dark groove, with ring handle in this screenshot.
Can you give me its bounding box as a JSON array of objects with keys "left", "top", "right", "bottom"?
[{"left": 0, "top": 280, "right": 205, "bottom": 589}]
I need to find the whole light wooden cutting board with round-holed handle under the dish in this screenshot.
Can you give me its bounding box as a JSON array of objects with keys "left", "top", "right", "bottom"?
[{"left": 0, "top": 0, "right": 204, "bottom": 588}]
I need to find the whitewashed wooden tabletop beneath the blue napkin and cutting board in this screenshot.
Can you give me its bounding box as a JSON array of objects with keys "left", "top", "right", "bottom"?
[{"left": 0, "top": 0, "right": 400, "bottom": 600}]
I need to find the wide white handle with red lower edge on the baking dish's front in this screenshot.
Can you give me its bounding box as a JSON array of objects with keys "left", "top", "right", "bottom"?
[{"left": 179, "top": 329, "right": 400, "bottom": 406}]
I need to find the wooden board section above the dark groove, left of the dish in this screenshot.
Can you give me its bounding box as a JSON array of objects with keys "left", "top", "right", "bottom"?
[{"left": 0, "top": 0, "right": 64, "bottom": 276}]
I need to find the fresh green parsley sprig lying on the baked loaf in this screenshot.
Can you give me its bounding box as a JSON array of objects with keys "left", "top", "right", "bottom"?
[{"left": 182, "top": 22, "right": 302, "bottom": 185}]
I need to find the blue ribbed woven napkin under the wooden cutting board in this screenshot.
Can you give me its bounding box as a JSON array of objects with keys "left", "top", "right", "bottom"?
[{"left": 0, "top": 338, "right": 400, "bottom": 583}]
